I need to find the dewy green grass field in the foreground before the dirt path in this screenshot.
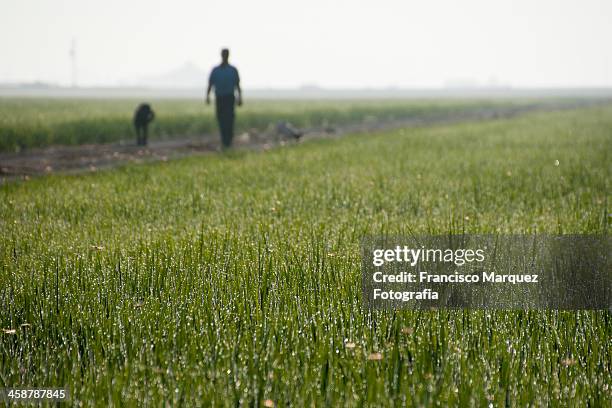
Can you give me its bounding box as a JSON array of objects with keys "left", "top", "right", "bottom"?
[{"left": 0, "top": 106, "right": 612, "bottom": 407}]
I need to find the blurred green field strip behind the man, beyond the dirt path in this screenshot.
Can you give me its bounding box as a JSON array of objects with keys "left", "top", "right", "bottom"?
[{"left": 0, "top": 96, "right": 605, "bottom": 152}]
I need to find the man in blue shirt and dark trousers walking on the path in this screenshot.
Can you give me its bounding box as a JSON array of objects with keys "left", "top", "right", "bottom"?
[{"left": 206, "top": 48, "right": 242, "bottom": 149}]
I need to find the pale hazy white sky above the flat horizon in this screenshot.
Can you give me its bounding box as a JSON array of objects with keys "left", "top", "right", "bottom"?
[{"left": 0, "top": 0, "right": 612, "bottom": 88}]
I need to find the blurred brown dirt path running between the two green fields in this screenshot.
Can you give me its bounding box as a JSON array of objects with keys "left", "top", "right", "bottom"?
[{"left": 0, "top": 101, "right": 601, "bottom": 183}]
